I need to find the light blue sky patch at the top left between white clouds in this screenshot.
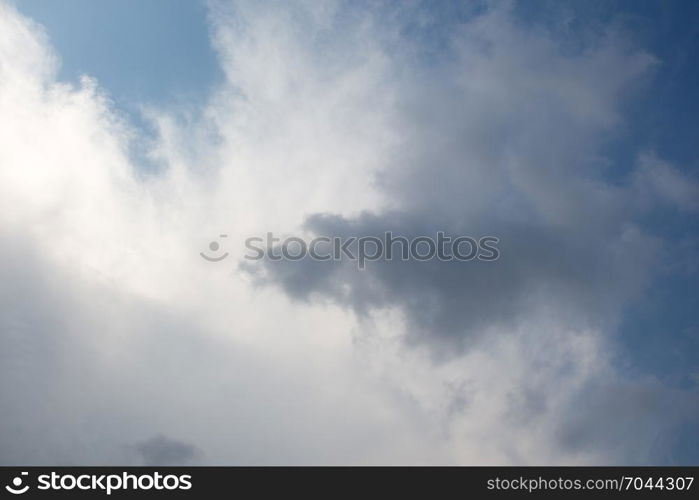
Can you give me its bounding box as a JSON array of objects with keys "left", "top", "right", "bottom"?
[{"left": 18, "top": 0, "right": 221, "bottom": 109}]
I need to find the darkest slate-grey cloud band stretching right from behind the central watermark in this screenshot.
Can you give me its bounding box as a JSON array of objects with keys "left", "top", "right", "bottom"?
[{"left": 246, "top": 203, "right": 659, "bottom": 353}]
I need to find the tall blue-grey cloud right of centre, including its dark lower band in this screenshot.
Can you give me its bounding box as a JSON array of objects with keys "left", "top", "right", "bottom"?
[{"left": 246, "top": 3, "right": 661, "bottom": 356}]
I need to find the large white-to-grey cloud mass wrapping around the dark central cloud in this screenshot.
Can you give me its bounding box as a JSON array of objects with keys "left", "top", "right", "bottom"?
[{"left": 0, "top": 3, "right": 686, "bottom": 464}]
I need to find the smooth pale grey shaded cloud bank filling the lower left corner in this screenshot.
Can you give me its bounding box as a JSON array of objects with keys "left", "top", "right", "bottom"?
[{"left": 0, "top": 231, "right": 426, "bottom": 466}]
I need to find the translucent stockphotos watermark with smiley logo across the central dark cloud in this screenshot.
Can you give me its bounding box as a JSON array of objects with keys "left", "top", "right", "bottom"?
[{"left": 200, "top": 231, "right": 500, "bottom": 269}]
